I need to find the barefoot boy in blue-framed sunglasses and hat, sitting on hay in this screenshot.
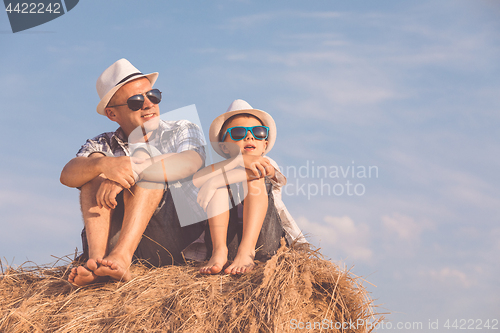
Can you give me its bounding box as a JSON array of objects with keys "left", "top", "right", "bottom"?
[{"left": 193, "top": 100, "right": 305, "bottom": 274}]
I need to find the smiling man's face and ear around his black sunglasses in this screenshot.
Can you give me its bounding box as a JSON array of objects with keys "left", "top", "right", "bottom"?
[{"left": 105, "top": 77, "right": 160, "bottom": 136}]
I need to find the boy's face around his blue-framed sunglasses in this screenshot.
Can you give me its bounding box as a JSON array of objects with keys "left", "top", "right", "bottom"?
[{"left": 219, "top": 116, "right": 267, "bottom": 157}]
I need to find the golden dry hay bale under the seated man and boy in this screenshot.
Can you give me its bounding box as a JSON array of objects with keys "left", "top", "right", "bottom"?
[{"left": 0, "top": 241, "right": 382, "bottom": 333}]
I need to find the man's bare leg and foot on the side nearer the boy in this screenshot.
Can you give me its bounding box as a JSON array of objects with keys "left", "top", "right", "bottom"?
[{"left": 94, "top": 184, "right": 164, "bottom": 281}]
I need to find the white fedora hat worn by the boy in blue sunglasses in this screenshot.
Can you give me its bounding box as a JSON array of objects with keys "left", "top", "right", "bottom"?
[{"left": 208, "top": 99, "right": 276, "bottom": 157}]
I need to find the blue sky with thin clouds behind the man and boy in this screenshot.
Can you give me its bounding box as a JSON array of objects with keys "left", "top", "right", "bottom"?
[{"left": 0, "top": 0, "right": 500, "bottom": 332}]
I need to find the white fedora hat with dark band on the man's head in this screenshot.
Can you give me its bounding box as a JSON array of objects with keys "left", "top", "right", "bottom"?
[{"left": 96, "top": 59, "right": 158, "bottom": 116}]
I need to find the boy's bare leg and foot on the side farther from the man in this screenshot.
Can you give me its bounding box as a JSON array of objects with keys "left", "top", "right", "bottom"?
[{"left": 224, "top": 178, "right": 268, "bottom": 274}]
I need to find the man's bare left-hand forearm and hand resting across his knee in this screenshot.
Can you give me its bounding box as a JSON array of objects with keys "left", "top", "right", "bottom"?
[{"left": 60, "top": 153, "right": 135, "bottom": 188}]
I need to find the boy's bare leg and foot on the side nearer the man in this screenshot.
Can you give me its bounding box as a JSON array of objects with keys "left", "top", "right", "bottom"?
[{"left": 200, "top": 188, "right": 229, "bottom": 274}]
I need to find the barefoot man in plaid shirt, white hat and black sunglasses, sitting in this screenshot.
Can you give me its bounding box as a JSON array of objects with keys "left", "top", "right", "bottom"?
[{"left": 61, "top": 59, "right": 205, "bottom": 286}]
